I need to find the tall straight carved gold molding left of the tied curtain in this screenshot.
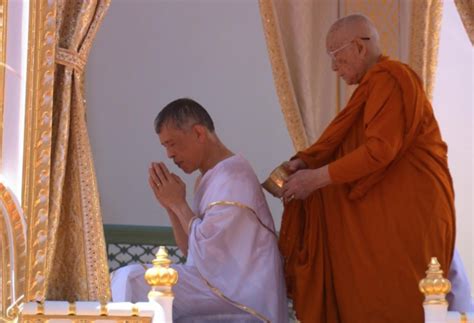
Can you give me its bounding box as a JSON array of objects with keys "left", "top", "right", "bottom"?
[{"left": 22, "top": 0, "right": 56, "bottom": 301}]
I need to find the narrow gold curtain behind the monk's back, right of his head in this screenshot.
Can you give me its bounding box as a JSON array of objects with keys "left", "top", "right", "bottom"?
[{"left": 408, "top": 0, "right": 443, "bottom": 99}]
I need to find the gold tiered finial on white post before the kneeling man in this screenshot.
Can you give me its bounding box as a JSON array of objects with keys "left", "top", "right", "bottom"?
[{"left": 145, "top": 246, "right": 178, "bottom": 295}]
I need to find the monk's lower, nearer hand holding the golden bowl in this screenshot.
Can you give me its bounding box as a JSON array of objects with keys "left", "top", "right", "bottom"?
[{"left": 283, "top": 165, "right": 331, "bottom": 203}]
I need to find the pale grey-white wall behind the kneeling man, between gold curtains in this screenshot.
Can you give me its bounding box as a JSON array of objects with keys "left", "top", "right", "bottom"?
[{"left": 86, "top": 0, "right": 293, "bottom": 228}]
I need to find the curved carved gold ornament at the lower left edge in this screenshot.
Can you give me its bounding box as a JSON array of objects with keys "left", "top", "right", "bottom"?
[{"left": 0, "top": 183, "right": 26, "bottom": 319}]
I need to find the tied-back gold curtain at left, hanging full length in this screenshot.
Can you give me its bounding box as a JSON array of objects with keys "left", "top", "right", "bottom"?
[{"left": 46, "top": 0, "right": 110, "bottom": 301}]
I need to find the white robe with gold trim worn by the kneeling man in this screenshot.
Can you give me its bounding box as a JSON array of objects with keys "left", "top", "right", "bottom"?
[{"left": 112, "top": 156, "right": 288, "bottom": 323}]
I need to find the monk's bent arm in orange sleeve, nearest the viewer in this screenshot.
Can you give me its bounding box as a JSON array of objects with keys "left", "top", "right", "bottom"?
[{"left": 328, "top": 73, "right": 405, "bottom": 183}]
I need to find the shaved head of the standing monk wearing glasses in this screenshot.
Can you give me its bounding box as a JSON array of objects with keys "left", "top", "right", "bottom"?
[{"left": 326, "top": 14, "right": 381, "bottom": 84}]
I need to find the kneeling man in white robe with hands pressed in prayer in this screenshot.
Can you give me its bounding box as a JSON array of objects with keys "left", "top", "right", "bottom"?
[{"left": 112, "top": 99, "right": 288, "bottom": 323}]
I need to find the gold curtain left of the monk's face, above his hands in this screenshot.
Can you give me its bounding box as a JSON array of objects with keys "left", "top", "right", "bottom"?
[{"left": 259, "top": 0, "right": 338, "bottom": 150}]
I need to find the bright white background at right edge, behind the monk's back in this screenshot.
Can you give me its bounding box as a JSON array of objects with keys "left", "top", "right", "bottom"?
[{"left": 433, "top": 0, "right": 474, "bottom": 294}]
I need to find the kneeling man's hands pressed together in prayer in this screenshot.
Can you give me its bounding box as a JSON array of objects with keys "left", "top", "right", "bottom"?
[{"left": 148, "top": 162, "right": 186, "bottom": 209}]
